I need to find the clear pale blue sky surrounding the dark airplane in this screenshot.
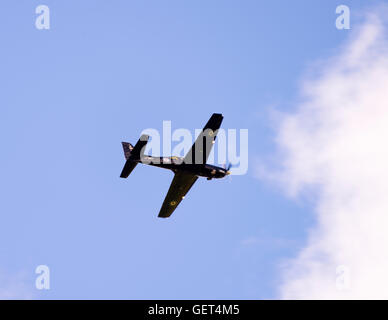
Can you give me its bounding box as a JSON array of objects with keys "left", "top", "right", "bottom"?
[{"left": 0, "top": 0, "right": 381, "bottom": 299}]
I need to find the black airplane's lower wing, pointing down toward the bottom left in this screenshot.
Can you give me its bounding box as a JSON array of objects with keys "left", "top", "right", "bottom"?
[{"left": 158, "top": 171, "right": 198, "bottom": 218}]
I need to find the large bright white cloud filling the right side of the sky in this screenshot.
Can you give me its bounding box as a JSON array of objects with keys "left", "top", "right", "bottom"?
[{"left": 266, "top": 8, "right": 388, "bottom": 299}]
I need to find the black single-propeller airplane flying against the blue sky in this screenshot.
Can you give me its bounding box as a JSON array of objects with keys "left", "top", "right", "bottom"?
[{"left": 120, "top": 113, "right": 231, "bottom": 218}]
